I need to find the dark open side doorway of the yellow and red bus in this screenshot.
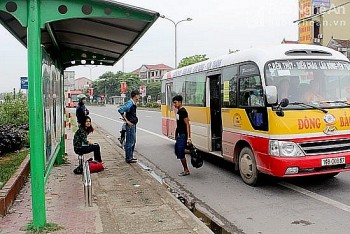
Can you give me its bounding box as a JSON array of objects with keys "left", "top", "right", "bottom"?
[{"left": 208, "top": 74, "right": 222, "bottom": 151}]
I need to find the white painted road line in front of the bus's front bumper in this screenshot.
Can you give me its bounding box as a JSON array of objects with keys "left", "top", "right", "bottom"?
[{"left": 278, "top": 182, "right": 350, "bottom": 213}]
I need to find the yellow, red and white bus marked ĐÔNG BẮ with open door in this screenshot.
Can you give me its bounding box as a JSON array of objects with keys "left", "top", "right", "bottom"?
[{"left": 161, "top": 44, "right": 350, "bottom": 185}]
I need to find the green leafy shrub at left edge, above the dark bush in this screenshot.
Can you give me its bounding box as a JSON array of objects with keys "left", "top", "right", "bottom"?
[{"left": 0, "top": 92, "right": 29, "bottom": 125}]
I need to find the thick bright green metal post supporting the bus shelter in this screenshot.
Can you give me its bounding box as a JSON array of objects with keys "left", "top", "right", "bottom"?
[{"left": 27, "top": 0, "right": 46, "bottom": 228}]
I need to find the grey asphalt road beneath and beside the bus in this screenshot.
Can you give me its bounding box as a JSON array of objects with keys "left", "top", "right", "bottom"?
[{"left": 89, "top": 106, "right": 350, "bottom": 234}]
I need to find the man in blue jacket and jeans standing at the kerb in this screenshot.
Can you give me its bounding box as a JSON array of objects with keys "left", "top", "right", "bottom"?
[{"left": 118, "top": 90, "right": 140, "bottom": 163}]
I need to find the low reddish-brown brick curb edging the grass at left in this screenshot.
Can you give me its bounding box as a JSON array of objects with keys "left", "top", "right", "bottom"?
[{"left": 0, "top": 155, "right": 30, "bottom": 216}]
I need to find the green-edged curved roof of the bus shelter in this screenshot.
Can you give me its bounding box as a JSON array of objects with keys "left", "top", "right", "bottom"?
[{"left": 0, "top": 0, "right": 159, "bottom": 68}]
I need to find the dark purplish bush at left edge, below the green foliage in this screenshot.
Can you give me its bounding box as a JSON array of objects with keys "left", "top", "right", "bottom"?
[{"left": 0, "top": 124, "right": 26, "bottom": 155}]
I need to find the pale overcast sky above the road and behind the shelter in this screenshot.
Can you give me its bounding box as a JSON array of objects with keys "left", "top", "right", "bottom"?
[{"left": 0, "top": 0, "right": 298, "bottom": 93}]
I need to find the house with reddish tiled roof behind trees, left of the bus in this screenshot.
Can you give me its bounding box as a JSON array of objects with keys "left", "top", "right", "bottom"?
[{"left": 133, "top": 64, "right": 173, "bottom": 83}]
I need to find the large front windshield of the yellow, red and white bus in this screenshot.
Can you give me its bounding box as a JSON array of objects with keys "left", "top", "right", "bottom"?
[{"left": 265, "top": 59, "right": 350, "bottom": 108}]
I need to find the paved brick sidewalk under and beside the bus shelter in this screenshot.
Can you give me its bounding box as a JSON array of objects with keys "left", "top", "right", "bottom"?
[{"left": 0, "top": 125, "right": 212, "bottom": 234}]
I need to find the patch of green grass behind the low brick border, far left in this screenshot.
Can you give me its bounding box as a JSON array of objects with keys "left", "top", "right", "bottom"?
[{"left": 0, "top": 149, "right": 29, "bottom": 189}]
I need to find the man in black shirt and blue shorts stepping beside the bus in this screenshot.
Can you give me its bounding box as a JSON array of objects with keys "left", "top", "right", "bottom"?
[{"left": 173, "top": 95, "right": 192, "bottom": 176}]
